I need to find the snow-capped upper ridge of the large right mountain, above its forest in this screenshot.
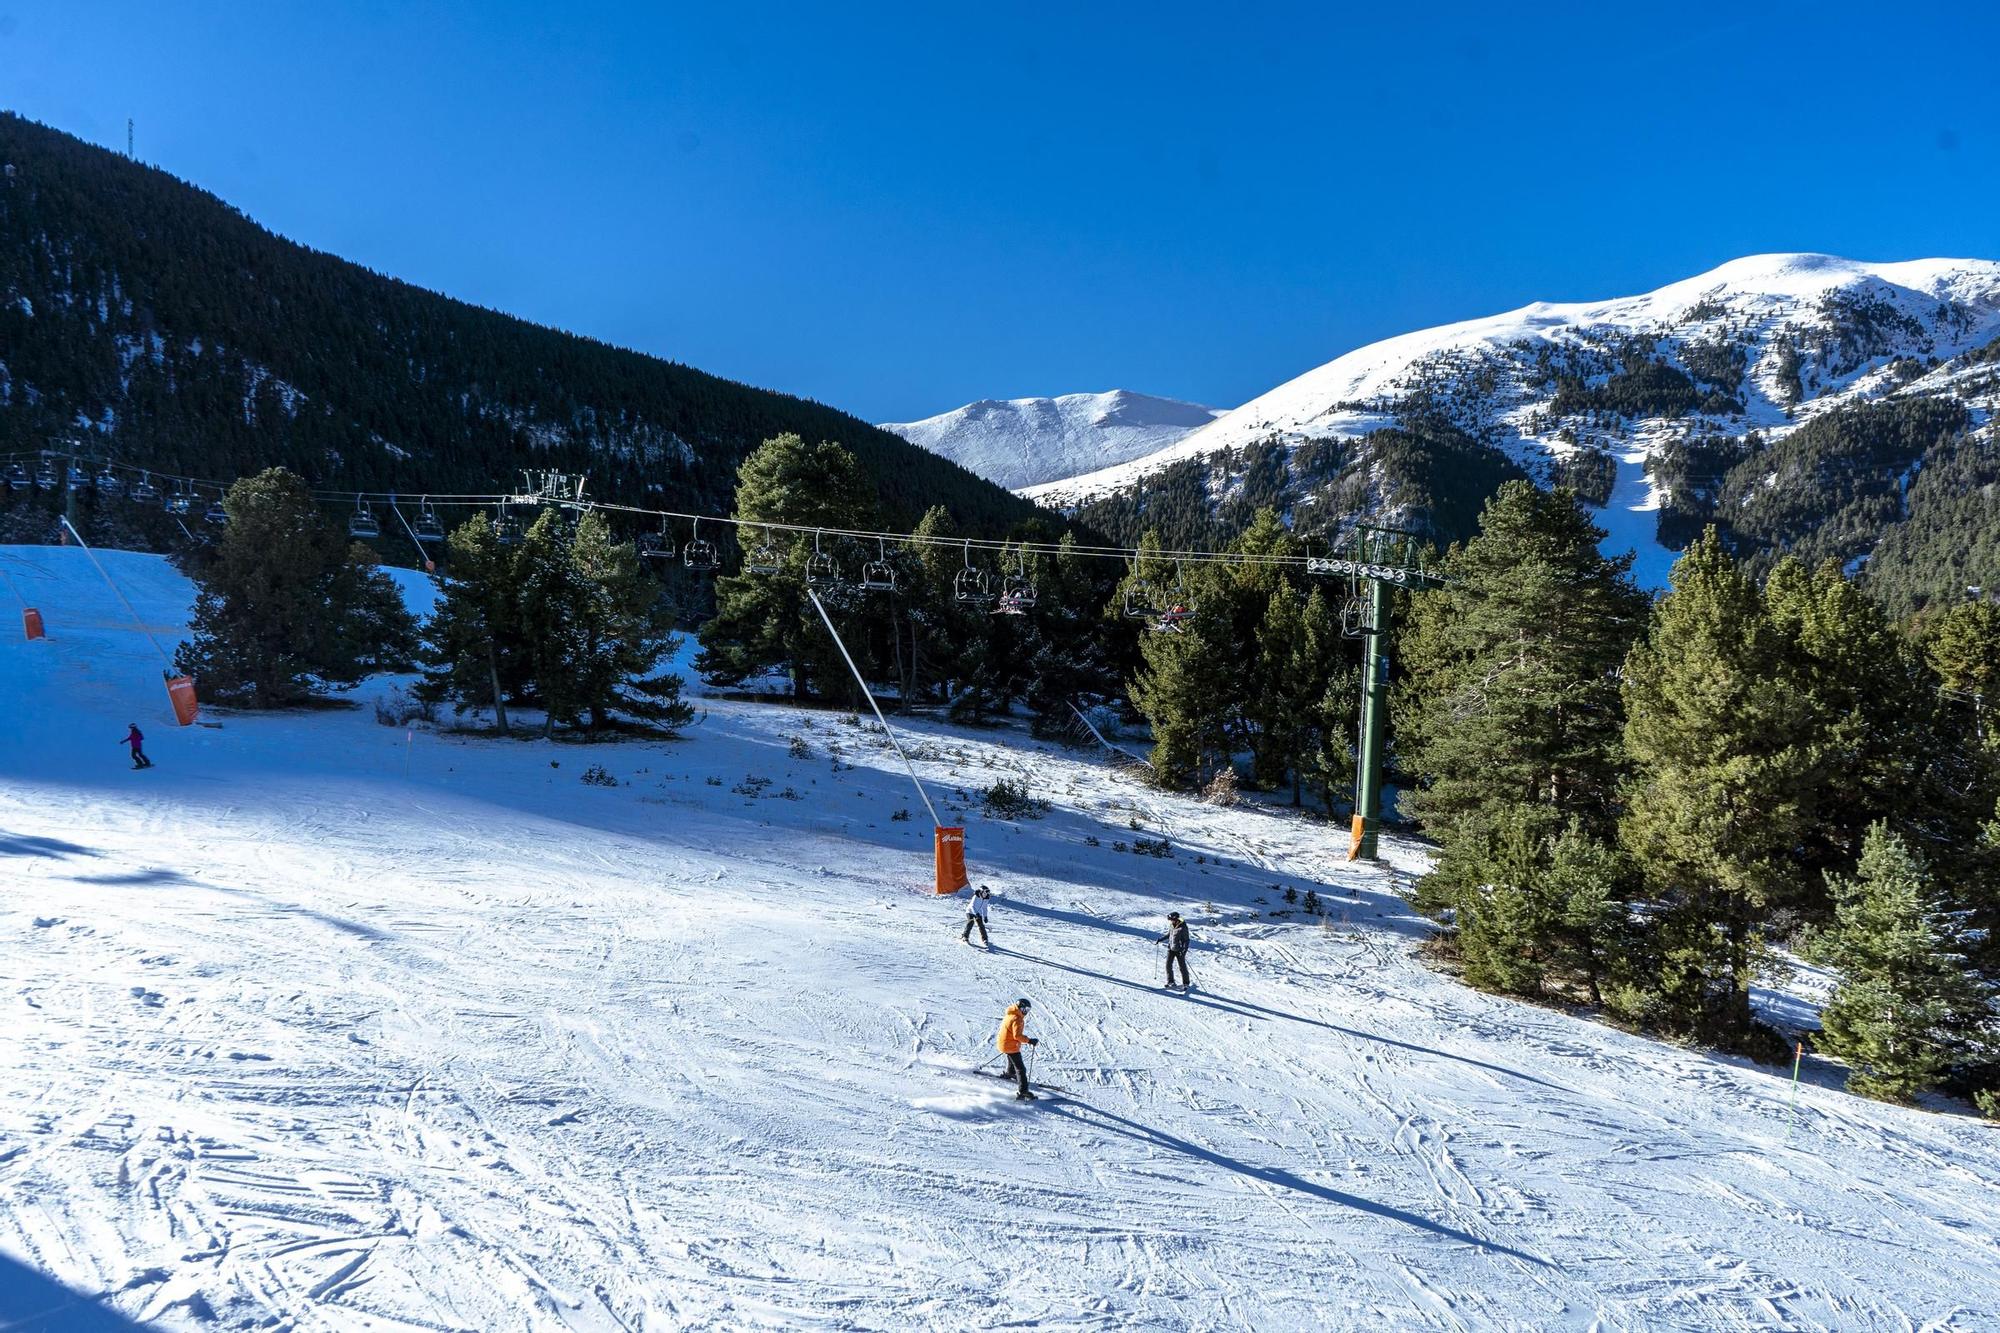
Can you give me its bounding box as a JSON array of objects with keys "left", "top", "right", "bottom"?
[{"left": 1028, "top": 254, "right": 2000, "bottom": 504}]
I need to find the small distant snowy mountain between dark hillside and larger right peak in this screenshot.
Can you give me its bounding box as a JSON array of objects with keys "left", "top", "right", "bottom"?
[{"left": 882, "top": 388, "right": 1220, "bottom": 488}]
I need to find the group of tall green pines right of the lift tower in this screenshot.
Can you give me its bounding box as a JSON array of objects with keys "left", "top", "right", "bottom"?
[{"left": 1396, "top": 486, "right": 2000, "bottom": 1105}]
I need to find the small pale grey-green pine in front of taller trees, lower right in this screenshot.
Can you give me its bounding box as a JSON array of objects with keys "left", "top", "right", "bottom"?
[{"left": 1818, "top": 825, "right": 1992, "bottom": 1101}]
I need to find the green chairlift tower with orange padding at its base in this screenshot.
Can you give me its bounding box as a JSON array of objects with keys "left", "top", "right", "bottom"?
[{"left": 1306, "top": 526, "right": 1442, "bottom": 861}]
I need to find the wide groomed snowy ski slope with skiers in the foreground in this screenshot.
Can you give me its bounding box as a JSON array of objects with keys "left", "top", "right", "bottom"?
[{"left": 0, "top": 548, "right": 2000, "bottom": 1329}]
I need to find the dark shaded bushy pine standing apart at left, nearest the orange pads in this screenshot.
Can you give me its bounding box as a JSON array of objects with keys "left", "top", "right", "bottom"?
[{"left": 174, "top": 468, "right": 416, "bottom": 709}]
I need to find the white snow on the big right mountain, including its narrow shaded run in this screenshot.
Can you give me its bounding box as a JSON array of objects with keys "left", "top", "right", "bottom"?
[{"left": 1024, "top": 254, "right": 2000, "bottom": 586}]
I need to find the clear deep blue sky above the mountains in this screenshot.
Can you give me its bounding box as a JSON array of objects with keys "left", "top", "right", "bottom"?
[{"left": 0, "top": 0, "right": 2000, "bottom": 420}]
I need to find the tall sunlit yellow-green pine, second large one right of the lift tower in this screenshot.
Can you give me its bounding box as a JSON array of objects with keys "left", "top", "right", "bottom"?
[{"left": 1618, "top": 528, "right": 1820, "bottom": 1043}]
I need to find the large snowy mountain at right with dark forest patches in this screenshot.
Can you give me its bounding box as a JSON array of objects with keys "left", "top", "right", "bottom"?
[{"left": 1028, "top": 254, "right": 2000, "bottom": 586}]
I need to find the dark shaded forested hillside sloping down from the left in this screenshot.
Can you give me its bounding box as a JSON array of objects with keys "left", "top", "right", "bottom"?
[{"left": 0, "top": 114, "right": 1034, "bottom": 532}]
